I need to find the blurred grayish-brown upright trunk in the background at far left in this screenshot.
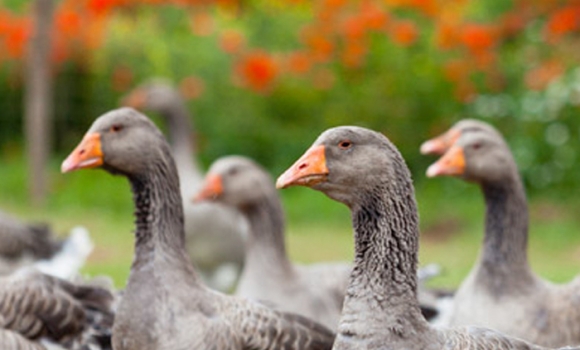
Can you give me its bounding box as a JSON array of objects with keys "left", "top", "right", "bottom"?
[{"left": 24, "top": 0, "right": 54, "bottom": 205}]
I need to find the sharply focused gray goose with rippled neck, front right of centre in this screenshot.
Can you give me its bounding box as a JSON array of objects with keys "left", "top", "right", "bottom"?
[{"left": 276, "top": 126, "right": 576, "bottom": 350}]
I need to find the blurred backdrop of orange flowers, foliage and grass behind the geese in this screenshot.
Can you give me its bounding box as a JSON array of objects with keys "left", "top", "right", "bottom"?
[{"left": 0, "top": 0, "right": 580, "bottom": 287}]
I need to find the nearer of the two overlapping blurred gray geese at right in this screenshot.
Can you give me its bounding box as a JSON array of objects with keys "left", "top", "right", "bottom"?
[{"left": 428, "top": 122, "right": 580, "bottom": 346}]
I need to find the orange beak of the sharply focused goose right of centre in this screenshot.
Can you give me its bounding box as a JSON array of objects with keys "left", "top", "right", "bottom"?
[{"left": 276, "top": 146, "right": 328, "bottom": 189}]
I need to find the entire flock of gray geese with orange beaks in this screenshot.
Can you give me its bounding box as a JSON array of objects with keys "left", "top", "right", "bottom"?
[{"left": 0, "top": 82, "right": 580, "bottom": 350}]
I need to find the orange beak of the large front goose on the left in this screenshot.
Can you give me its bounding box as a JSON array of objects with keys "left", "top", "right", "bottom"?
[{"left": 60, "top": 133, "right": 103, "bottom": 173}]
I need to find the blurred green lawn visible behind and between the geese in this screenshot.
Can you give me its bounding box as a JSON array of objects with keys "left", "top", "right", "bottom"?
[{"left": 0, "top": 154, "right": 580, "bottom": 287}]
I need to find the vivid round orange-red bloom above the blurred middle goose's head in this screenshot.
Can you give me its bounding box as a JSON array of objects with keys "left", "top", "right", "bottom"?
[{"left": 236, "top": 51, "right": 278, "bottom": 91}]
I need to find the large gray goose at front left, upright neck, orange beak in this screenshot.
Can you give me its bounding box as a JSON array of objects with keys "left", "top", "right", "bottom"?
[{"left": 62, "top": 108, "right": 334, "bottom": 350}]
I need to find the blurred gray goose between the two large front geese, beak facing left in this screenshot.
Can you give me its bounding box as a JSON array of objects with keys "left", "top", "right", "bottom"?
[{"left": 195, "top": 156, "right": 351, "bottom": 329}]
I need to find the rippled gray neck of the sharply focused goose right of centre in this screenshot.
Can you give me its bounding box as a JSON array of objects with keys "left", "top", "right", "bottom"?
[{"left": 339, "top": 150, "right": 428, "bottom": 339}]
